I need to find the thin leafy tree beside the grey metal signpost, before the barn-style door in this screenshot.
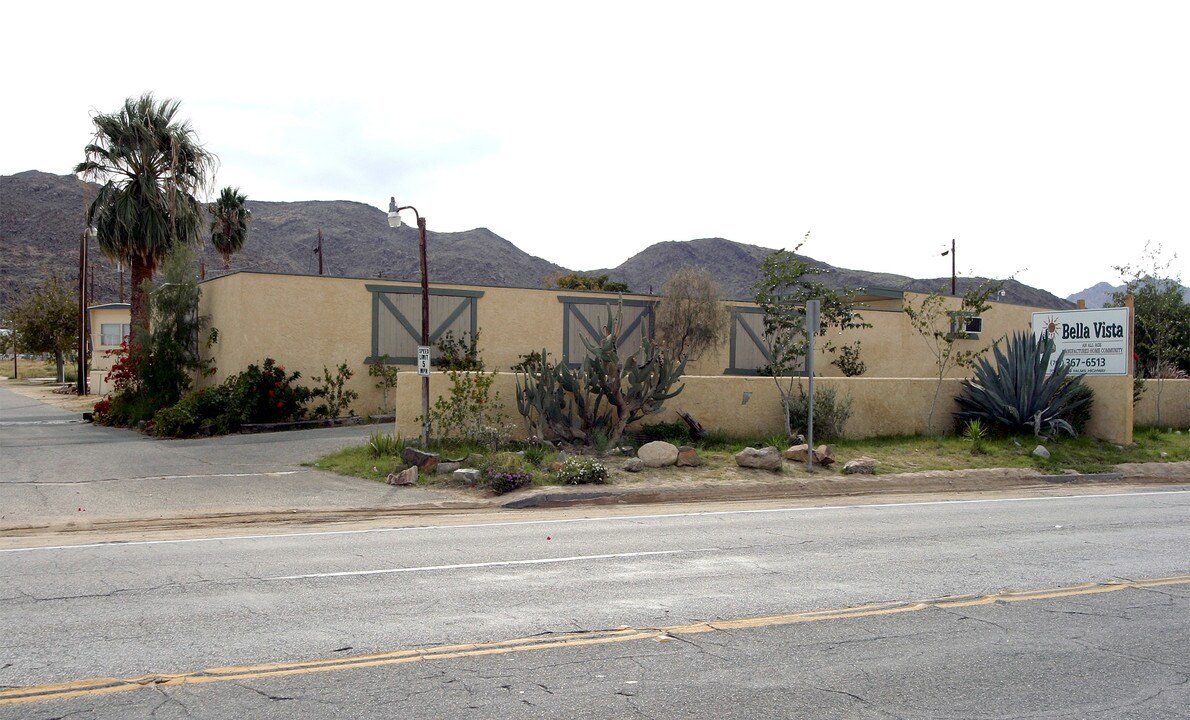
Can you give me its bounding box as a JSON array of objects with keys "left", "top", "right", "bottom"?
[{"left": 756, "top": 233, "right": 871, "bottom": 437}]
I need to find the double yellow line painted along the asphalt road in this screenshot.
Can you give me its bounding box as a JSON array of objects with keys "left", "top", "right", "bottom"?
[{"left": 0, "top": 575, "right": 1190, "bottom": 706}]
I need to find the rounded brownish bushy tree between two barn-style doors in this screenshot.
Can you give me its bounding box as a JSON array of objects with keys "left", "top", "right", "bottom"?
[{"left": 655, "top": 268, "right": 729, "bottom": 359}]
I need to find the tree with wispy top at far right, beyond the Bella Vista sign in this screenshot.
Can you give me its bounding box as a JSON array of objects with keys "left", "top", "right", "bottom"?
[{"left": 1109, "top": 243, "right": 1190, "bottom": 425}]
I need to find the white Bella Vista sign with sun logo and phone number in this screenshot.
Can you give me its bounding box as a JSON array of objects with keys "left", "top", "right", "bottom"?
[{"left": 1033, "top": 307, "right": 1128, "bottom": 375}]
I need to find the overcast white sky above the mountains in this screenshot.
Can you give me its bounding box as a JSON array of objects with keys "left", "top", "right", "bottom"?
[{"left": 0, "top": 0, "right": 1190, "bottom": 296}]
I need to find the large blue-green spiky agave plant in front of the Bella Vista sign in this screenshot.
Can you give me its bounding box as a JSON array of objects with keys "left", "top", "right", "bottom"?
[{"left": 954, "top": 332, "right": 1091, "bottom": 437}]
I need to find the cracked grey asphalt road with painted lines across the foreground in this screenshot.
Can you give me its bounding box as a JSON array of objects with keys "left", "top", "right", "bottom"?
[{"left": 0, "top": 487, "right": 1190, "bottom": 719}]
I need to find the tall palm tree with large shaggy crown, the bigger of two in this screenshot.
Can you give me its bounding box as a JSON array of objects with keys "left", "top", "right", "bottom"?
[{"left": 75, "top": 93, "right": 218, "bottom": 340}]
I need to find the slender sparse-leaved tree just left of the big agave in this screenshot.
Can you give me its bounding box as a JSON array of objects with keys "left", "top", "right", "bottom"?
[{"left": 903, "top": 274, "right": 1004, "bottom": 434}]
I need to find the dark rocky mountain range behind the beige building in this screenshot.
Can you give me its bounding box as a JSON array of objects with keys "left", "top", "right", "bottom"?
[{"left": 0, "top": 170, "right": 1080, "bottom": 309}]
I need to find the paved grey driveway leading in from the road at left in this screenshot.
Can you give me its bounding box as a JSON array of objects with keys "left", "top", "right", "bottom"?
[{"left": 0, "top": 388, "right": 453, "bottom": 530}]
